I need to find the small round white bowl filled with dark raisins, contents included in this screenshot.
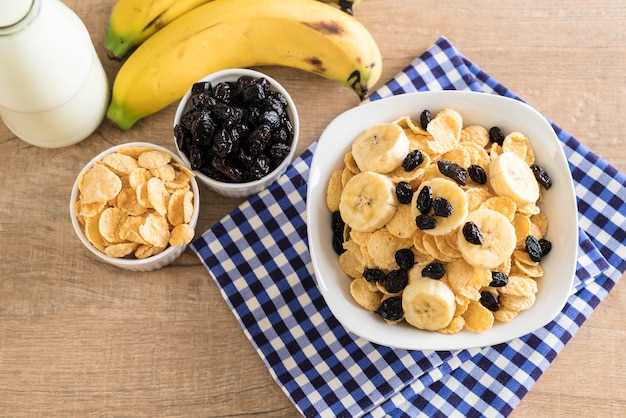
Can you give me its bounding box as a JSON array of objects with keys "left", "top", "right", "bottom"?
[{"left": 174, "top": 68, "right": 300, "bottom": 198}]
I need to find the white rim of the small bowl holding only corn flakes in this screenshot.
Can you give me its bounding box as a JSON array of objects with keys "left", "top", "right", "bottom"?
[{"left": 70, "top": 141, "right": 200, "bottom": 267}]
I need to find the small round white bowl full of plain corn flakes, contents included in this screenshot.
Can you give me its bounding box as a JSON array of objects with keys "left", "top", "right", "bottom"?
[{"left": 70, "top": 142, "right": 200, "bottom": 271}]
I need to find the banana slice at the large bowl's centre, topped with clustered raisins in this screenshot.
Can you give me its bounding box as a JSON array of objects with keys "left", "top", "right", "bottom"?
[{"left": 411, "top": 177, "right": 468, "bottom": 235}]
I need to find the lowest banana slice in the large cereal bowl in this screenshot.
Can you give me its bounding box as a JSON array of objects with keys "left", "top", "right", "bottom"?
[{"left": 402, "top": 276, "right": 456, "bottom": 331}]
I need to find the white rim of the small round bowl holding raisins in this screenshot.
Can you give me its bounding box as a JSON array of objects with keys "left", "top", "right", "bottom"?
[{"left": 173, "top": 68, "right": 300, "bottom": 192}]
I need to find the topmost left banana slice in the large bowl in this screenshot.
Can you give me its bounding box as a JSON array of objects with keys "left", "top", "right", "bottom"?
[{"left": 352, "top": 123, "right": 409, "bottom": 174}]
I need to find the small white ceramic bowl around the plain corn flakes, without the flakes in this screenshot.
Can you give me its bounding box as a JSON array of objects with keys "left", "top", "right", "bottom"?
[{"left": 70, "top": 142, "right": 200, "bottom": 271}]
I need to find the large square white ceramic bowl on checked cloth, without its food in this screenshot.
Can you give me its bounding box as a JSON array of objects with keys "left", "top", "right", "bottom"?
[{"left": 307, "top": 91, "right": 578, "bottom": 350}]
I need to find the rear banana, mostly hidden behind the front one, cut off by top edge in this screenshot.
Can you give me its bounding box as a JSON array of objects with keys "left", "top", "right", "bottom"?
[{"left": 104, "top": 0, "right": 361, "bottom": 60}]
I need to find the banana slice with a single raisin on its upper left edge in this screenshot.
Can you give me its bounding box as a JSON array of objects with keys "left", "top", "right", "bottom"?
[{"left": 457, "top": 209, "right": 517, "bottom": 269}]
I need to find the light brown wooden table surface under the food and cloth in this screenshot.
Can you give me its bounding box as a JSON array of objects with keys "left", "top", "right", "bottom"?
[{"left": 0, "top": 0, "right": 626, "bottom": 417}]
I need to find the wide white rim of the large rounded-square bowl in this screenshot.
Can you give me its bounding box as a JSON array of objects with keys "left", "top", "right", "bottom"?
[{"left": 306, "top": 90, "right": 578, "bottom": 350}]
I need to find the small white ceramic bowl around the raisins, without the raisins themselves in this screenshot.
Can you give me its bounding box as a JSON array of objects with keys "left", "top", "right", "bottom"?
[{"left": 174, "top": 68, "right": 300, "bottom": 198}]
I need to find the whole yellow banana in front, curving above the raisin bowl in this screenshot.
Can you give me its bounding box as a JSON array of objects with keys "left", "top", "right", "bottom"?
[{"left": 107, "top": 0, "right": 382, "bottom": 130}]
